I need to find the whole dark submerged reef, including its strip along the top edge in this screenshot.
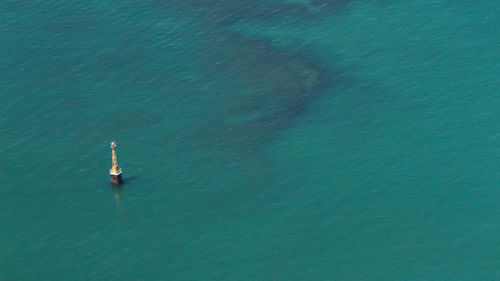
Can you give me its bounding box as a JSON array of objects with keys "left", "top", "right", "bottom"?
[{"left": 151, "top": 0, "right": 350, "bottom": 147}]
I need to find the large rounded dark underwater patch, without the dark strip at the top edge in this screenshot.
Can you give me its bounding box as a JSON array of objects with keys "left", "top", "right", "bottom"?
[{"left": 186, "top": 32, "right": 331, "bottom": 148}]
